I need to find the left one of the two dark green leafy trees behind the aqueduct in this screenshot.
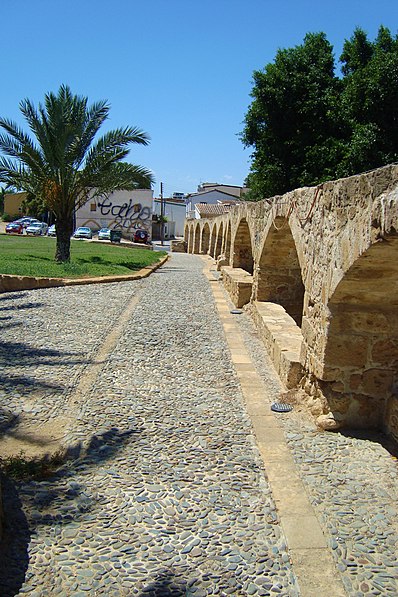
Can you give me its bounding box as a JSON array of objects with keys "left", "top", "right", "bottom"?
[{"left": 242, "top": 33, "right": 343, "bottom": 198}]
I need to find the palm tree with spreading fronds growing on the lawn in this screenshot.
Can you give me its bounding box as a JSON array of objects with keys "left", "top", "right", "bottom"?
[{"left": 0, "top": 85, "right": 153, "bottom": 262}]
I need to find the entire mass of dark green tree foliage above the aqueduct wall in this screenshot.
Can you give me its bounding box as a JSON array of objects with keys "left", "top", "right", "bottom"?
[{"left": 241, "top": 27, "right": 398, "bottom": 200}]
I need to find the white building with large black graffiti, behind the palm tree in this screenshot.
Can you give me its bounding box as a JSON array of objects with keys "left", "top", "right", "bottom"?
[{"left": 76, "top": 189, "right": 153, "bottom": 240}]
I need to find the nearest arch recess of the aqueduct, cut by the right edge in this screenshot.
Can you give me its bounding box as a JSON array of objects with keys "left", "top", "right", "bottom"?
[{"left": 320, "top": 234, "right": 398, "bottom": 440}]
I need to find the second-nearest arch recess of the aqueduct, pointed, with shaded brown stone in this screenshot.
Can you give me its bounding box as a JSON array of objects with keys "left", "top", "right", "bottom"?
[{"left": 255, "top": 217, "right": 304, "bottom": 326}]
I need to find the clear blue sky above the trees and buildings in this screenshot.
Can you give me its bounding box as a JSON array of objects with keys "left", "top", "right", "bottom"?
[{"left": 0, "top": 0, "right": 398, "bottom": 195}]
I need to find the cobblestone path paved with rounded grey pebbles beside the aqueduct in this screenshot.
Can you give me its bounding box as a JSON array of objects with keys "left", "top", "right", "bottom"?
[{"left": 0, "top": 254, "right": 398, "bottom": 597}]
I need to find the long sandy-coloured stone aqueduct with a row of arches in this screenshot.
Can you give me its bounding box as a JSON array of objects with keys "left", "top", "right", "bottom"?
[{"left": 184, "top": 165, "right": 398, "bottom": 440}]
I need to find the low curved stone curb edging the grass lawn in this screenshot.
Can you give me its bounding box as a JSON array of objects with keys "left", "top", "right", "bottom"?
[{"left": 0, "top": 255, "right": 169, "bottom": 293}]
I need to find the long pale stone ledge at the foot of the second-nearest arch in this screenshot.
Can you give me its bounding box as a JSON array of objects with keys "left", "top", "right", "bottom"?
[{"left": 251, "top": 301, "right": 303, "bottom": 388}]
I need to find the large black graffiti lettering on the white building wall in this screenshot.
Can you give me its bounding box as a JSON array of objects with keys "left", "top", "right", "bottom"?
[{"left": 97, "top": 197, "right": 152, "bottom": 233}]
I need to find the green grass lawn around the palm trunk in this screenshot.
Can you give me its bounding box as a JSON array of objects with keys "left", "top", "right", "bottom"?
[{"left": 0, "top": 234, "right": 166, "bottom": 278}]
